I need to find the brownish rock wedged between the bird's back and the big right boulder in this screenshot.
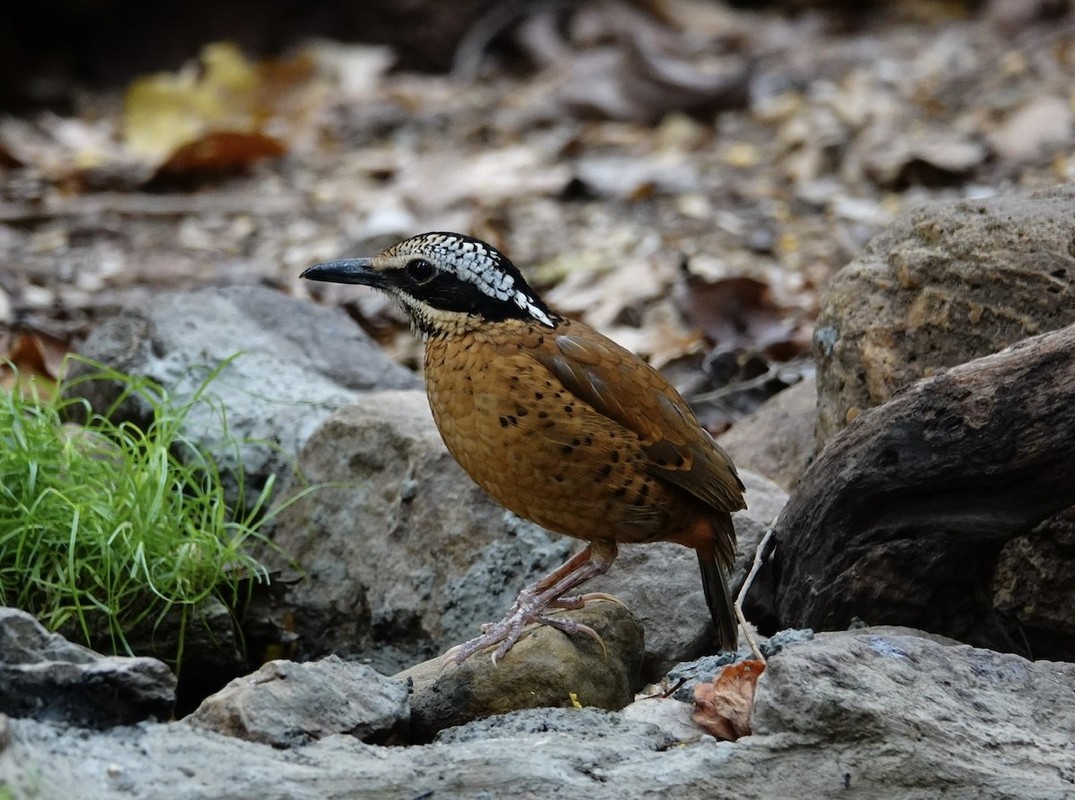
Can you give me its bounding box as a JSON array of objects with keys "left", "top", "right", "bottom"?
[{"left": 717, "top": 374, "right": 817, "bottom": 491}]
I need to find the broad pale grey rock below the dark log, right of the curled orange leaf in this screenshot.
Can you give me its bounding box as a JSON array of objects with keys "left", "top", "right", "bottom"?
[{"left": 753, "top": 631, "right": 1075, "bottom": 797}]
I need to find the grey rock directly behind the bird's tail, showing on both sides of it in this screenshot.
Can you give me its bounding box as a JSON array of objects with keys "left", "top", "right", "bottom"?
[{"left": 586, "top": 470, "right": 788, "bottom": 681}]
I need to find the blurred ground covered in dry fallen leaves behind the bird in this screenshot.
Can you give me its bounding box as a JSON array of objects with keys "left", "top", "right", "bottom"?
[{"left": 0, "top": 0, "right": 1075, "bottom": 421}]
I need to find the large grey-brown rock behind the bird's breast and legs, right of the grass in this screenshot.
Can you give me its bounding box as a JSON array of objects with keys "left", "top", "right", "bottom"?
[{"left": 268, "top": 391, "right": 571, "bottom": 672}]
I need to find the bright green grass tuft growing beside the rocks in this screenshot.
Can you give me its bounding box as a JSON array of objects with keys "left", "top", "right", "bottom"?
[{"left": 0, "top": 362, "right": 288, "bottom": 663}]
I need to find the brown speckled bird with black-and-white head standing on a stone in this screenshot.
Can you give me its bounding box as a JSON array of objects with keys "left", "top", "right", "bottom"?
[{"left": 301, "top": 232, "right": 746, "bottom": 663}]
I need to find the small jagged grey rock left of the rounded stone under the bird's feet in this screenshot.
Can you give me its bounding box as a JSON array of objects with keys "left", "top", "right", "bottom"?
[{"left": 185, "top": 656, "right": 411, "bottom": 747}]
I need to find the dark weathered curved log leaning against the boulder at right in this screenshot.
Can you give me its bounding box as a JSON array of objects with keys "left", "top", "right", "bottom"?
[{"left": 775, "top": 325, "right": 1075, "bottom": 660}]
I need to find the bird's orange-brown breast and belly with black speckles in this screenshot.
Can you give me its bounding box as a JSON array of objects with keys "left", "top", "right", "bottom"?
[{"left": 426, "top": 338, "right": 697, "bottom": 542}]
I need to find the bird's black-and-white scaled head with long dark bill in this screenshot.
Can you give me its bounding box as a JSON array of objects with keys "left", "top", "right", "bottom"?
[{"left": 302, "top": 233, "right": 560, "bottom": 338}]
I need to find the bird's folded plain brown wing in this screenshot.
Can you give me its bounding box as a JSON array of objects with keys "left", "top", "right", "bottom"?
[{"left": 535, "top": 323, "right": 746, "bottom": 512}]
